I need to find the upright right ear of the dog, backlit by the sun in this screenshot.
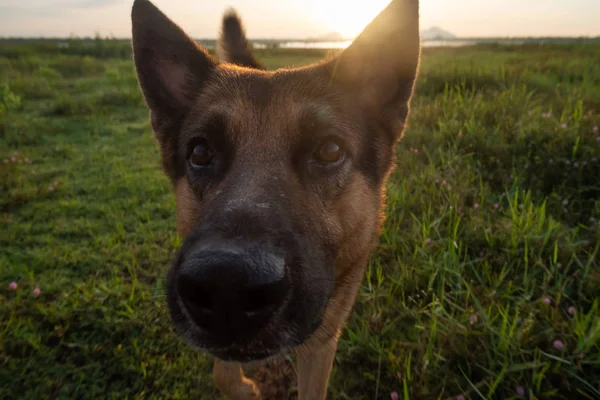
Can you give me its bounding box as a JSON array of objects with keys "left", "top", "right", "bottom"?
[{"left": 326, "top": 0, "right": 421, "bottom": 140}]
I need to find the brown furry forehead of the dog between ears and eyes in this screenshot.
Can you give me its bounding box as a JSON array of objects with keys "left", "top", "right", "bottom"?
[{"left": 188, "top": 67, "right": 347, "bottom": 148}]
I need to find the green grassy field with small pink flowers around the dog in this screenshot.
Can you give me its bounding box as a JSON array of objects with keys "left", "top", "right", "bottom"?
[{"left": 0, "top": 40, "right": 600, "bottom": 399}]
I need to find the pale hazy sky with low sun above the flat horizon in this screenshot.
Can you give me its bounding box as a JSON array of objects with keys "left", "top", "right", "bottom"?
[{"left": 0, "top": 0, "right": 600, "bottom": 39}]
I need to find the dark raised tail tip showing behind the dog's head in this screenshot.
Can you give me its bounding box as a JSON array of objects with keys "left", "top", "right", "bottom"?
[{"left": 217, "top": 8, "right": 266, "bottom": 69}]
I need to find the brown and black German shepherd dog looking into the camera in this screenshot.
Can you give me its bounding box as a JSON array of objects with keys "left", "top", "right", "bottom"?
[{"left": 132, "top": 0, "right": 421, "bottom": 400}]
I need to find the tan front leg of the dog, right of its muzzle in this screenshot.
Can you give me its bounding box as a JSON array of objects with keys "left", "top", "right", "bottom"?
[{"left": 296, "top": 261, "right": 366, "bottom": 400}]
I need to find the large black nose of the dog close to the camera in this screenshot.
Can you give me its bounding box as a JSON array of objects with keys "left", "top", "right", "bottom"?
[{"left": 177, "top": 248, "right": 288, "bottom": 341}]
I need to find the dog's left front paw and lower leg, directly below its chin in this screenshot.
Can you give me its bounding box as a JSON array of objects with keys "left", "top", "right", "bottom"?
[{"left": 213, "top": 360, "right": 260, "bottom": 400}]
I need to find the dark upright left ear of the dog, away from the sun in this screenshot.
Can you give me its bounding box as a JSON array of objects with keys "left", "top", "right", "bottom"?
[{"left": 131, "top": 0, "right": 217, "bottom": 133}]
